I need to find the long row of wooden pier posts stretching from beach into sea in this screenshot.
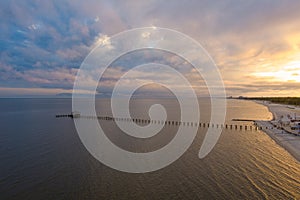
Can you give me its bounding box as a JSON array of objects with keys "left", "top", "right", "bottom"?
[{"left": 56, "top": 114, "right": 268, "bottom": 130}]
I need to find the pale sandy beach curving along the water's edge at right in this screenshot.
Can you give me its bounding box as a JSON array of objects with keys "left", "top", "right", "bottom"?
[{"left": 255, "top": 101, "right": 300, "bottom": 162}]
